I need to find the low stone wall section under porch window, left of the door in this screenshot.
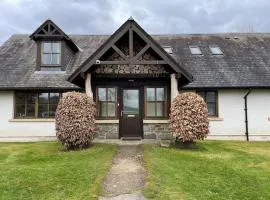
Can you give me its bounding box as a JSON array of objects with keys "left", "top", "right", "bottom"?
[{"left": 96, "top": 124, "right": 119, "bottom": 139}]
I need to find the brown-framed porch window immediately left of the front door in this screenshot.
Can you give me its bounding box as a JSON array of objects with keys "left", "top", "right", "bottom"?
[{"left": 97, "top": 87, "right": 117, "bottom": 117}]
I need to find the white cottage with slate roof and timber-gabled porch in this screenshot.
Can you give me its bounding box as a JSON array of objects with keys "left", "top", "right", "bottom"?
[{"left": 0, "top": 19, "right": 270, "bottom": 140}]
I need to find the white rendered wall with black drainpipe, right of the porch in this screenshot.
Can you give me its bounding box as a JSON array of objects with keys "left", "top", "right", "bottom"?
[{"left": 208, "top": 89, "right": 270, "bottom": 140}]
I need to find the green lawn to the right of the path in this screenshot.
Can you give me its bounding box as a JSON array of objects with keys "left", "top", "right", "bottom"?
[{"left": 144, "top": 141, "right": 270, "bottom": 200}]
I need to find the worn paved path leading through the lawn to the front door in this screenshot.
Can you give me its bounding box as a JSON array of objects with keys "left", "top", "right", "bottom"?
[{"left": 99, "top": 145, "right": 146, "bottom": 200}]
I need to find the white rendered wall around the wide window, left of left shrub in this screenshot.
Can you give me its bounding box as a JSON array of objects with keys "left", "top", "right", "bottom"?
[{"left": 0, "top": 91, "right": 55, "bottom": 139}]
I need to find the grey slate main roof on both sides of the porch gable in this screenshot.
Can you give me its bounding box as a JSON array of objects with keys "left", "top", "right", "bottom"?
[{"left": 0, "top": 33, "right": 270, "bottom": 90}]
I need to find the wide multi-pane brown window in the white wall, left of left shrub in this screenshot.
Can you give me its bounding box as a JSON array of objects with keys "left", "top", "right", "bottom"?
[{"left": 15, "top": 92, "right": 61, "bottom": 118}]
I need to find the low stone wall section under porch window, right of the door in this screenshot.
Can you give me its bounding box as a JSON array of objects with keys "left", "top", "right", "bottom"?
[{"left": 143, "top": 123, "right": 172, "bottom": 140}]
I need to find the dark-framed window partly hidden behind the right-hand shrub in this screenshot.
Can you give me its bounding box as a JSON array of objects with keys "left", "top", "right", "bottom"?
[{"left": 197, "top": 91, "right": 218, "bottom": 117}]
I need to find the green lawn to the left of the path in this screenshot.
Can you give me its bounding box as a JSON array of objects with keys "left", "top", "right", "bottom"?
[{"left": 0, "top": 142, "right": 116, "bottom": 200}]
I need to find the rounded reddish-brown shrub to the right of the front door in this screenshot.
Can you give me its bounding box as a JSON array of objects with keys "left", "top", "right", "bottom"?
[{"left": 170, "top": 92, "right": 209, "bottom": 143}]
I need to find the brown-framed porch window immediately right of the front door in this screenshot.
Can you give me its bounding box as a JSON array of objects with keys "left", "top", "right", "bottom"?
[{"left": 145, "top": 87, "right": 166, "bottom": 117}]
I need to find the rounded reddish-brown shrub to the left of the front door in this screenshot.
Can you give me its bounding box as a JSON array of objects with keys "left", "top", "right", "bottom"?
[{"left": 55, "top": 92, "right": 96, "bottom": 150}]
